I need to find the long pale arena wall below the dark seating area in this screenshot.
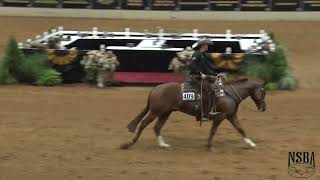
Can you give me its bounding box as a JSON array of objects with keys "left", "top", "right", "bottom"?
[{"left": 0, "top": 7, "right": 320, "bottom": 21}]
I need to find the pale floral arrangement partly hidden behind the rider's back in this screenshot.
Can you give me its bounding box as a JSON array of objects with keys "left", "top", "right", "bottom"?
[{"left": 168, "top": 47, "right": 194, "bottom": 75}]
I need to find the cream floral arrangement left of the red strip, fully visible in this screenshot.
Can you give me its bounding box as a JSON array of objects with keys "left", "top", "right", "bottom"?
[{"left": 81, "top": 49, "right": 120, "bottom": 87}]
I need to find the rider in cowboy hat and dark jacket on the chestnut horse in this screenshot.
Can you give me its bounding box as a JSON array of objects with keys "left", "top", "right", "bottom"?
[{"left": 190, "top": 39, "right": 219, "bottom": 119}]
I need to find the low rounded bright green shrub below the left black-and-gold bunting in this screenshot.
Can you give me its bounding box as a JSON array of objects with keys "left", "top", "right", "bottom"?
[{"left": 36, "top": 69, "right": 62, "bottom": 86}]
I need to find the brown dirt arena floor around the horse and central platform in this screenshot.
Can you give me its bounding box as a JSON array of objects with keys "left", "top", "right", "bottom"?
[{"left": 0, "top": 17, "right": 320, "bottom": 180}]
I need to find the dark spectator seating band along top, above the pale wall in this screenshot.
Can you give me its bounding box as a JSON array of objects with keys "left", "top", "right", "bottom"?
[{"left": 0, "top": 0, "right": 320, "bottom": 11}]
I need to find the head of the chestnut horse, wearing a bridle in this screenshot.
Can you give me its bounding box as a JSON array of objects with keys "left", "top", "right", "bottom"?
[{"left": 249, "top": 80, "right": 266, "bottom": 112}]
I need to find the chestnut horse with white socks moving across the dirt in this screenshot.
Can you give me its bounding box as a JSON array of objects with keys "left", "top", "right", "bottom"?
[{"left": 121, "top": 78, "right": 266, "bottom": 150}]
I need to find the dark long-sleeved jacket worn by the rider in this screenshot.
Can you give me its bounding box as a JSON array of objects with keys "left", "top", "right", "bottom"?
[{"left": 190, "top": 51, "right": 218, "bottom": 75}]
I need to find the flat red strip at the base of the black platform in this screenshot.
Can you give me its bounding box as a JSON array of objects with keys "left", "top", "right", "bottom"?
[{"left": 113, "top": 72, "right": 182, "bottom": 83}]
